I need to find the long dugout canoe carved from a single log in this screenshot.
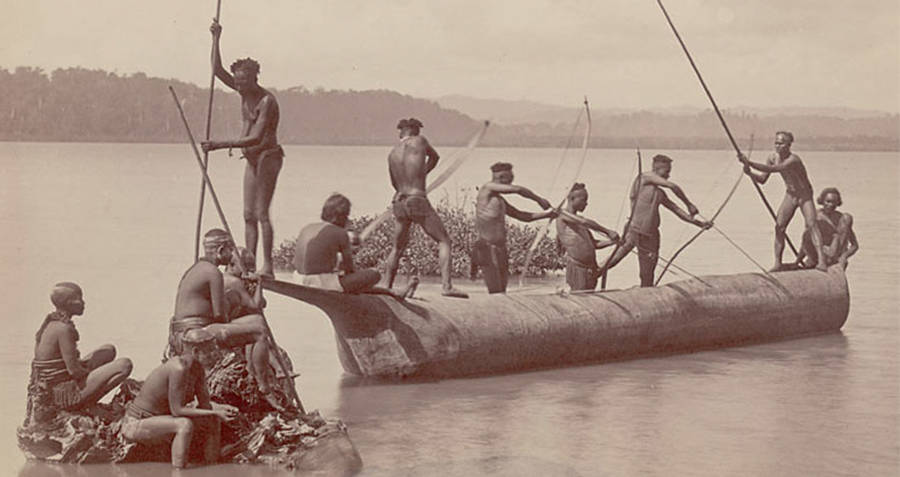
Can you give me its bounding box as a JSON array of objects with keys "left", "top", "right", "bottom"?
[{"left": 265, "top": 266, "right": 850, "bottom": 377}]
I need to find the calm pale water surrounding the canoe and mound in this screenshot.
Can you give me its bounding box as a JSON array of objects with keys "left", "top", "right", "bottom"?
[{"left": 0, "top": 143, "right": 900, "bottom": 477}]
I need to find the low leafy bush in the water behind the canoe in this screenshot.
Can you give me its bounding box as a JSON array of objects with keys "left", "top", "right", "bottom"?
[{"left": 274, "top": 198, "right": 566, "bottom": 277}]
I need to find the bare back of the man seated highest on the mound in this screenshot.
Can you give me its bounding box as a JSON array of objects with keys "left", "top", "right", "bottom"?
[{"left": 174, "top": 259, "right": 224, "bottom": 319}]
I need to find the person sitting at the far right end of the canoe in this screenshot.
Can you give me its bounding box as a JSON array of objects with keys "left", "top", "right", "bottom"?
[{"left": 796, "top": 187, "right": 859, "bottom": 269}]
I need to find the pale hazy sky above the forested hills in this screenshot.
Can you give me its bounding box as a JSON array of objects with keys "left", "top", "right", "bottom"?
[{"left": 0, "top": 0, "right": 900, "bottom": 113}]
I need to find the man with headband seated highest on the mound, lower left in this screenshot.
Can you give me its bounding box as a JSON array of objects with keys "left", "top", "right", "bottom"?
[{"left": 166, "top": 229, "right": 281, "bottom": 409}]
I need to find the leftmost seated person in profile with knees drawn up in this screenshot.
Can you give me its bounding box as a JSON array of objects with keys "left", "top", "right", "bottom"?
[{"left": 26, "top": 282, "right": 132, "bottom": 421}]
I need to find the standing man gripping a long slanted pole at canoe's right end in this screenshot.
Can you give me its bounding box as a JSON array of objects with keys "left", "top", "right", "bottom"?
[{"left": 738, "top": 131, "right": 826, "bottom": 272}]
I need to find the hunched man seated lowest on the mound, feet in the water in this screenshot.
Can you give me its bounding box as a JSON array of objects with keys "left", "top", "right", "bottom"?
[{"left": 122, "top": 329, "right": 238, "bottom": 468}]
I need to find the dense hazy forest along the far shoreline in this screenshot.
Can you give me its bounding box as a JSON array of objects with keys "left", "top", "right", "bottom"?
[{"left": 0, "top": 67, "right": 900, "bottom": 151}]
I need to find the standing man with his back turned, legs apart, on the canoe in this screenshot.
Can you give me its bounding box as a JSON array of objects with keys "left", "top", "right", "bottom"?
[{"left": 387, "top": 118, "right": 468, "bottom": 298}]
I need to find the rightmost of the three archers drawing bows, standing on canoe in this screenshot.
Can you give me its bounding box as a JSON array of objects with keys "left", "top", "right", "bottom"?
[{"left": 600, "top": 154, "right": 712, "bottom": 287}]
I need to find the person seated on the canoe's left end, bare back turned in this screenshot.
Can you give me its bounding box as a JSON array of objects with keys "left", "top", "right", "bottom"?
[{"left": 294, "top": 193, "right": 419, "bottom": 299}]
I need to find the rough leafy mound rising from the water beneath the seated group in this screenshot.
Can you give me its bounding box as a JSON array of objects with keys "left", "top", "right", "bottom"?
[{"left": 16, "top": 350, "right": 361, "bottom": 473}]
